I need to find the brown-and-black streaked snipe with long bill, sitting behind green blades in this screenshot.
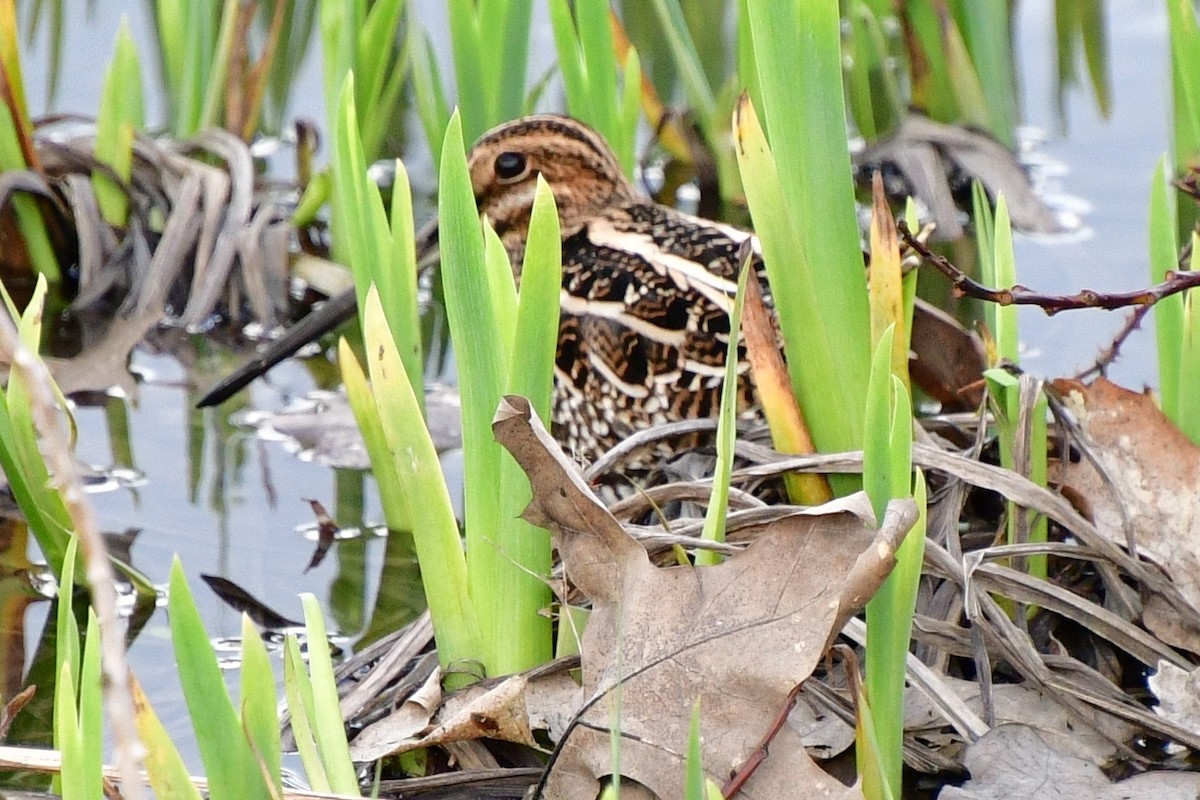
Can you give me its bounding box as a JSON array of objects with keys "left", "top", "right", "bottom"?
[{"left": 202, "top": 115, "right": 761, "bottom": 463}]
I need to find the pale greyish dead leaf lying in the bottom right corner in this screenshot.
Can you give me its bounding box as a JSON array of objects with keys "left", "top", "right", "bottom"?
[{"left": 937, "top": 724, "right": 1200, "bottom": 800}]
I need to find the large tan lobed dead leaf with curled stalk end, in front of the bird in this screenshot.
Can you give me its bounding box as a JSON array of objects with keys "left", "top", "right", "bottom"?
[{"left": 492, "top": 397, "right": 916, "bottom": 800}]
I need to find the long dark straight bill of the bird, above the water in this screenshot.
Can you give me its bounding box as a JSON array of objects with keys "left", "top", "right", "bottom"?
[{"left": 196, "top": 219, "right": 438, "bottom": 408}]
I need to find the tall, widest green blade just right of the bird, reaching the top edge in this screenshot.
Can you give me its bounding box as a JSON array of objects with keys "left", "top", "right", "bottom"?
[{"left": 739, "top": 0, "right": 870, "bottom": 450}]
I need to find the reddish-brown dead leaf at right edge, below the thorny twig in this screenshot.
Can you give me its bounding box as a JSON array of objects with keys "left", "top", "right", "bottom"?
[{"left": 1054, "top": 378, "right": 1200, "bottom": 652}]
